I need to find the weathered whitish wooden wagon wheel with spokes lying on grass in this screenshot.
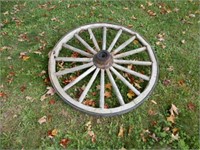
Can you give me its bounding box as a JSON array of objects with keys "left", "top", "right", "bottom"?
[{"left": 48, "top": 23, "right": 158, "bottom": 116}]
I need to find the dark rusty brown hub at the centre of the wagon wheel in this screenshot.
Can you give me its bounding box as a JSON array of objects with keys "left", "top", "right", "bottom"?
[{"left": 93, "top": 50, "right": 113, "bottom": 69}]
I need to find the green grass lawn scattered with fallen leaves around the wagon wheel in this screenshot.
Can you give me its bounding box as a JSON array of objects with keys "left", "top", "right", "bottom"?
[{"left": 0, "top": 0, "right": 200, "bottom": 150}]
